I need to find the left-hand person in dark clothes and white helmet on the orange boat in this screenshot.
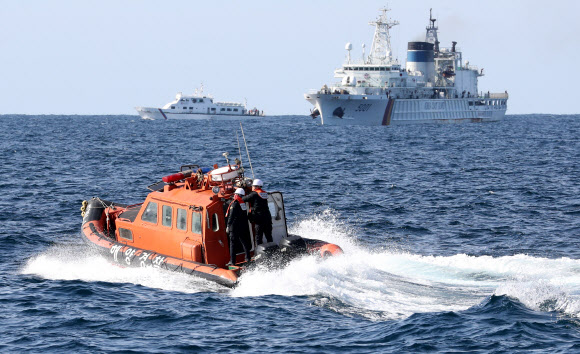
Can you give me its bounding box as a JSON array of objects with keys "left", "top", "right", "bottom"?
[{"left": 226, "top": 188, "right": 252, "bottom": 265}]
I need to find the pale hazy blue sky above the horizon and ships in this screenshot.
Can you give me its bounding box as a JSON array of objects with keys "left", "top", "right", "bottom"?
[{"left": 0, "top": 0, "right": 580, "bottom": 114}]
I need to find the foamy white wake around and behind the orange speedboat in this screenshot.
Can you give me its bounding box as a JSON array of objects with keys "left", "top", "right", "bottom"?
[{"left": 22, "top": 213, "right": 580, "bottom": 319}]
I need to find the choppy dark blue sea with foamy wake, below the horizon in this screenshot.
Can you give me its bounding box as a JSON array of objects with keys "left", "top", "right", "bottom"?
[{"left": 0, "top": 114, "right": 580, "bottom": 353}]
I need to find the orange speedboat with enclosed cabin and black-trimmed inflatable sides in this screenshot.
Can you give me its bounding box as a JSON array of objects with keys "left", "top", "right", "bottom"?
[{"left": 81, "top": 158, "right": 342, "bottom": 287}]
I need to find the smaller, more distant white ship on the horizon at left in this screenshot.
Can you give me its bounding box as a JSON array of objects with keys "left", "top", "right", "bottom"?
[{"left": 135, "top": 85, "right": 264, "bottom": 120}]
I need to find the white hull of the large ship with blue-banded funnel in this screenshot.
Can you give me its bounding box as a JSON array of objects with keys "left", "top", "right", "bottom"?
[{"left": 305, "top": 94, "right": 507, "bottom": 125}]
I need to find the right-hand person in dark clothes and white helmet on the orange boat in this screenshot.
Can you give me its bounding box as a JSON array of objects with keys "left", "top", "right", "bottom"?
[{"left": 242, "top": 178, "right": 272, "bottom": 245}]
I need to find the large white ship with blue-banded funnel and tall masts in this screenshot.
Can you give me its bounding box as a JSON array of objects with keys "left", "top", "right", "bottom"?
[{"left": 304, "top": 8, "right": 508, "bottom": 125}]
